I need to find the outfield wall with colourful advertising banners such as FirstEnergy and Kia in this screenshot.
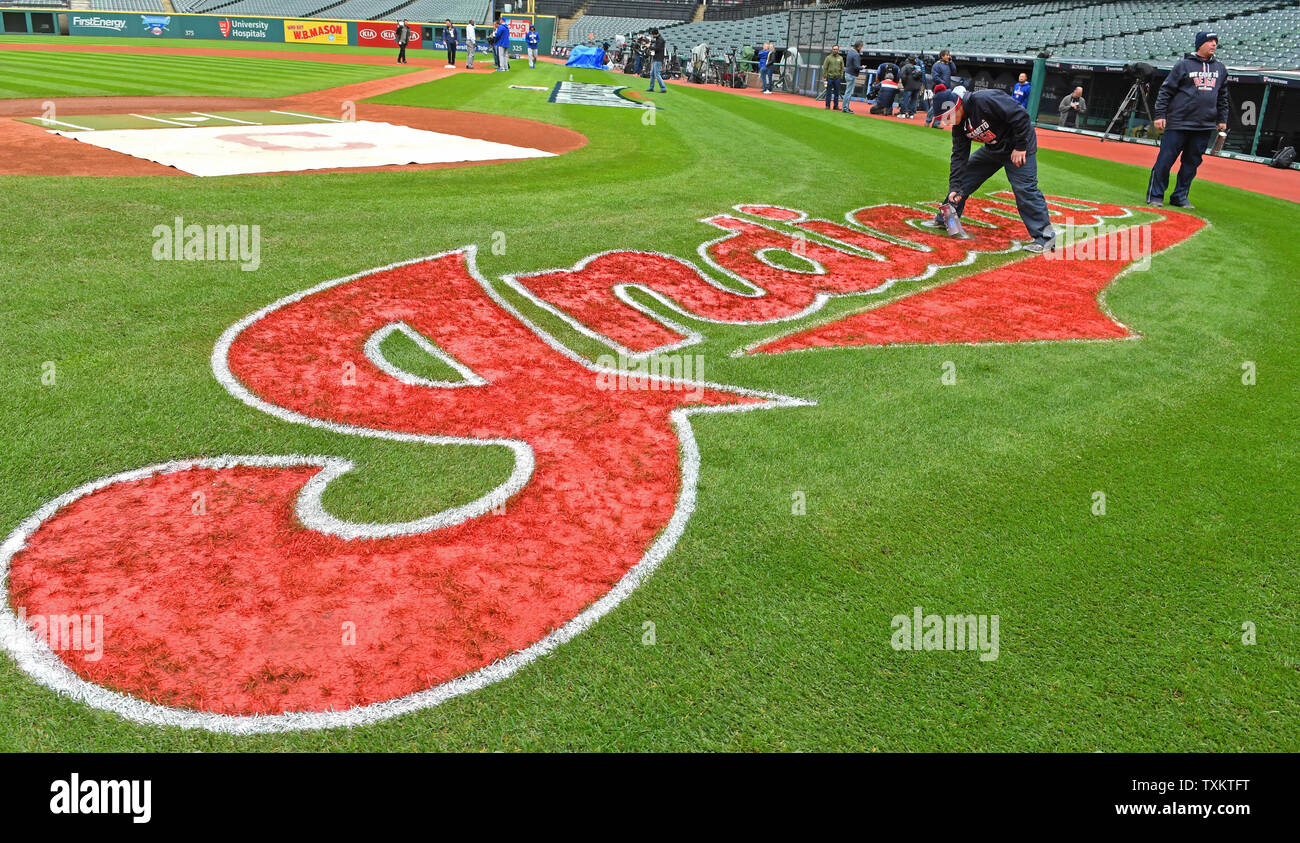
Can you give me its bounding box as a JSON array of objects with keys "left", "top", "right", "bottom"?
[{"left": 0, "top": 9, "right": 555, "bottom": 53}]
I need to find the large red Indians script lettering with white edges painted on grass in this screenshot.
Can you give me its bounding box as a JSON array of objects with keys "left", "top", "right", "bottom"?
[{"left": 0, "top": 199, "right": 1204, "bottom": 732}]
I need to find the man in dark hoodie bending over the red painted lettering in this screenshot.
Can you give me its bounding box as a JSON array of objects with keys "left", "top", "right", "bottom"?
[{"left": 924, "top": 88, "right": 1056, "bottom": 254}]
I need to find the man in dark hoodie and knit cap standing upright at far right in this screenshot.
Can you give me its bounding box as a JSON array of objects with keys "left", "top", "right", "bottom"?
[{"left": 1147, "top": 33, "right": 1229, "bottom": 208}]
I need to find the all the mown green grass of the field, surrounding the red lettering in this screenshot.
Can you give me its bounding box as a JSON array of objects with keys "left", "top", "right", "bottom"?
[{"left": 0, "top": 53, "right": 1300, "bottom": 752}]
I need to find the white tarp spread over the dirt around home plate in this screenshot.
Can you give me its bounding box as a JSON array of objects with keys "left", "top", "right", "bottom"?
[{"left": 56, "top": 120, "right": 554, "bottom": 176}]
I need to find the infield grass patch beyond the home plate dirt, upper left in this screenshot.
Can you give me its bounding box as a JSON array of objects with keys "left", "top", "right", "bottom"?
[{"left": 0, "top": 51, "right": 410, "bottom": 99}]
